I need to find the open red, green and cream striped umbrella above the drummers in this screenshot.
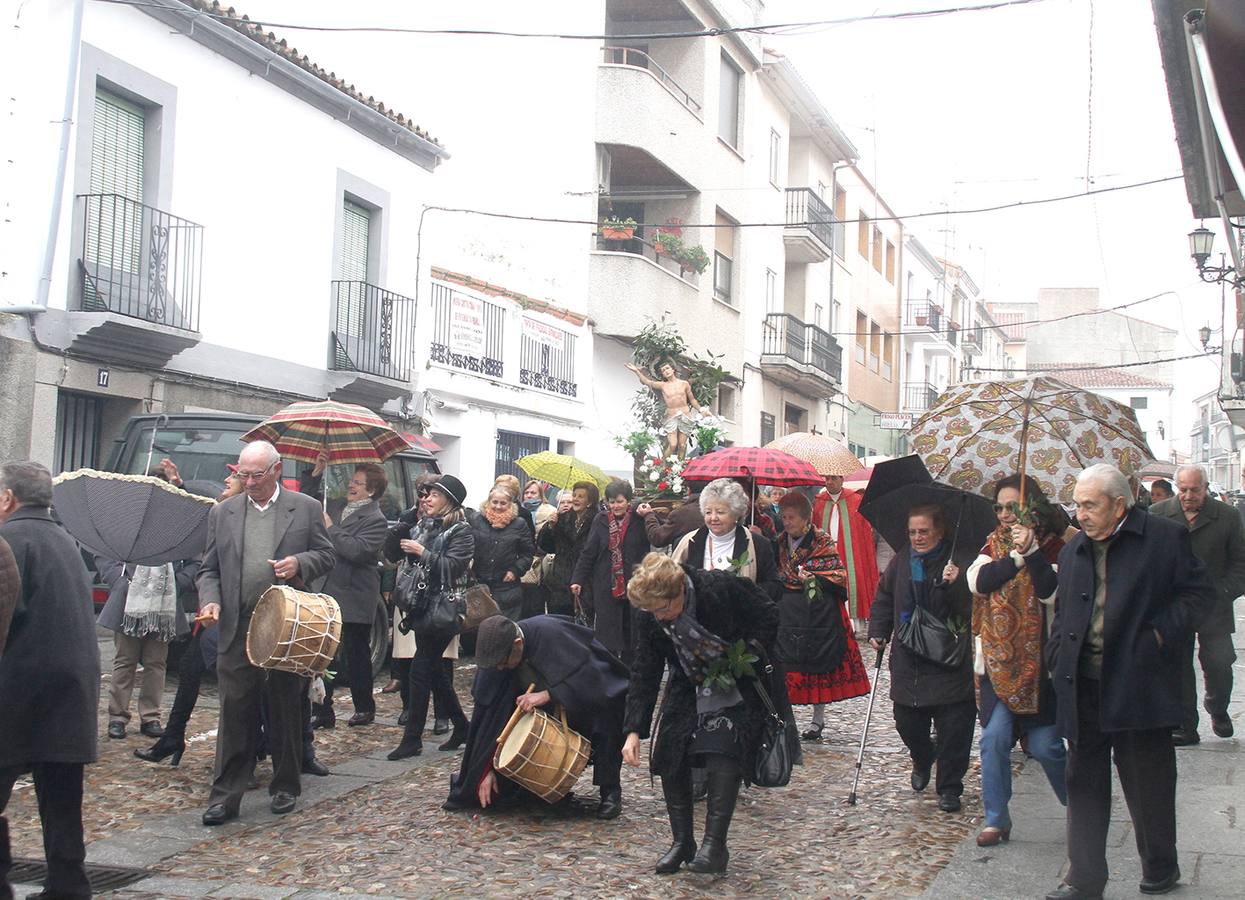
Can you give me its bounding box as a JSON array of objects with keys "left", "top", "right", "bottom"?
[{"left": 242, "top": 400, "right": 410, "bottom": 464}]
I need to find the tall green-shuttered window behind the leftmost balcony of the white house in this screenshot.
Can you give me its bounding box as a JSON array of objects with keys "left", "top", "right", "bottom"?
[{"left": 82, "top": 90, "right": 144, "bottom": 309}]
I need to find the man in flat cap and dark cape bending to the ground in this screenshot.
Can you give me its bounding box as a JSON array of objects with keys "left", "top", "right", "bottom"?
[{"left": 444, "top": 615, "right": 630, "bottom": 819}]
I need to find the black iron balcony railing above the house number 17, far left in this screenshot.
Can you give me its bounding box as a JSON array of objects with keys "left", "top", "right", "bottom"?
[{"left": 77, "top": 194, "right": 203, "bottom": 331}]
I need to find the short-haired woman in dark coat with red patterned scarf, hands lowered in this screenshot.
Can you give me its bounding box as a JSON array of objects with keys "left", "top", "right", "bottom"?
[{"left": 570, "top": 479, "right": 652, "bottom": 665}]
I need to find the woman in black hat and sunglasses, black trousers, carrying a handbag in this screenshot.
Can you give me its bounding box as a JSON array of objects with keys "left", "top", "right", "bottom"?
[{"left": 385, "top": 476, "right": 476, "bottom": 759}]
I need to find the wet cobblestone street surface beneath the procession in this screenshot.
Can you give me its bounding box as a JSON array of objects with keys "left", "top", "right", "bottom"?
[{"left": 9, "top": 637, "right": 980, "bottom": 898}]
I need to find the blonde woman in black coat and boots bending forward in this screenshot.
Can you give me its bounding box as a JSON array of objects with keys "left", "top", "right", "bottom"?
[{"left": 623, "top": 553, "right": 778, "bottom": 874}]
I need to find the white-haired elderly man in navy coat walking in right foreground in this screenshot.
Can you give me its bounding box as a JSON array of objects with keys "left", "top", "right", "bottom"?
[{"left": 1046, "top": 463, "right": 1214, "bottom": 900}]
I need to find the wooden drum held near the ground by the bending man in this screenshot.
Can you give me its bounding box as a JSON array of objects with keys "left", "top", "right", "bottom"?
[{"left": 493, "top": 710, "right": 593, "bottom": 803}]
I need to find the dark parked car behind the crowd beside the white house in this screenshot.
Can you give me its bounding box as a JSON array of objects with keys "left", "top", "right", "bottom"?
[{"left": 91, "top": 412, "right": 441, "bottom": 672}]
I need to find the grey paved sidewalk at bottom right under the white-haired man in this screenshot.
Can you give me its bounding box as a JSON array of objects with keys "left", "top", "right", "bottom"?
[{"left": 923, "top": 619, "right": 1245, "bottom": 900}]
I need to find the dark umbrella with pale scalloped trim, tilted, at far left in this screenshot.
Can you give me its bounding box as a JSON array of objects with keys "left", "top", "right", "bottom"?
[{"left": 52, "top": 469, "right": 215, "bottom": 565}]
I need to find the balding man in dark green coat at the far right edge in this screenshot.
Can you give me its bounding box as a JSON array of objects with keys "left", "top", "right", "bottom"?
[{"left": 1150, "top": 466, "right": 1245, "bottom": 747}]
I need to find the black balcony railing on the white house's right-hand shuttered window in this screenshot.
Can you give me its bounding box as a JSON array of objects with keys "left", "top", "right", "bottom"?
[{"left": 329, "top": 281, "right": 415, "bottom": 382}]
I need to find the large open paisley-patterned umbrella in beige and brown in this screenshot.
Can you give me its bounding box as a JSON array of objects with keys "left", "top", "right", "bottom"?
[{"left": 908, "top": 375, "right": 1154, "bottom": 503}]
